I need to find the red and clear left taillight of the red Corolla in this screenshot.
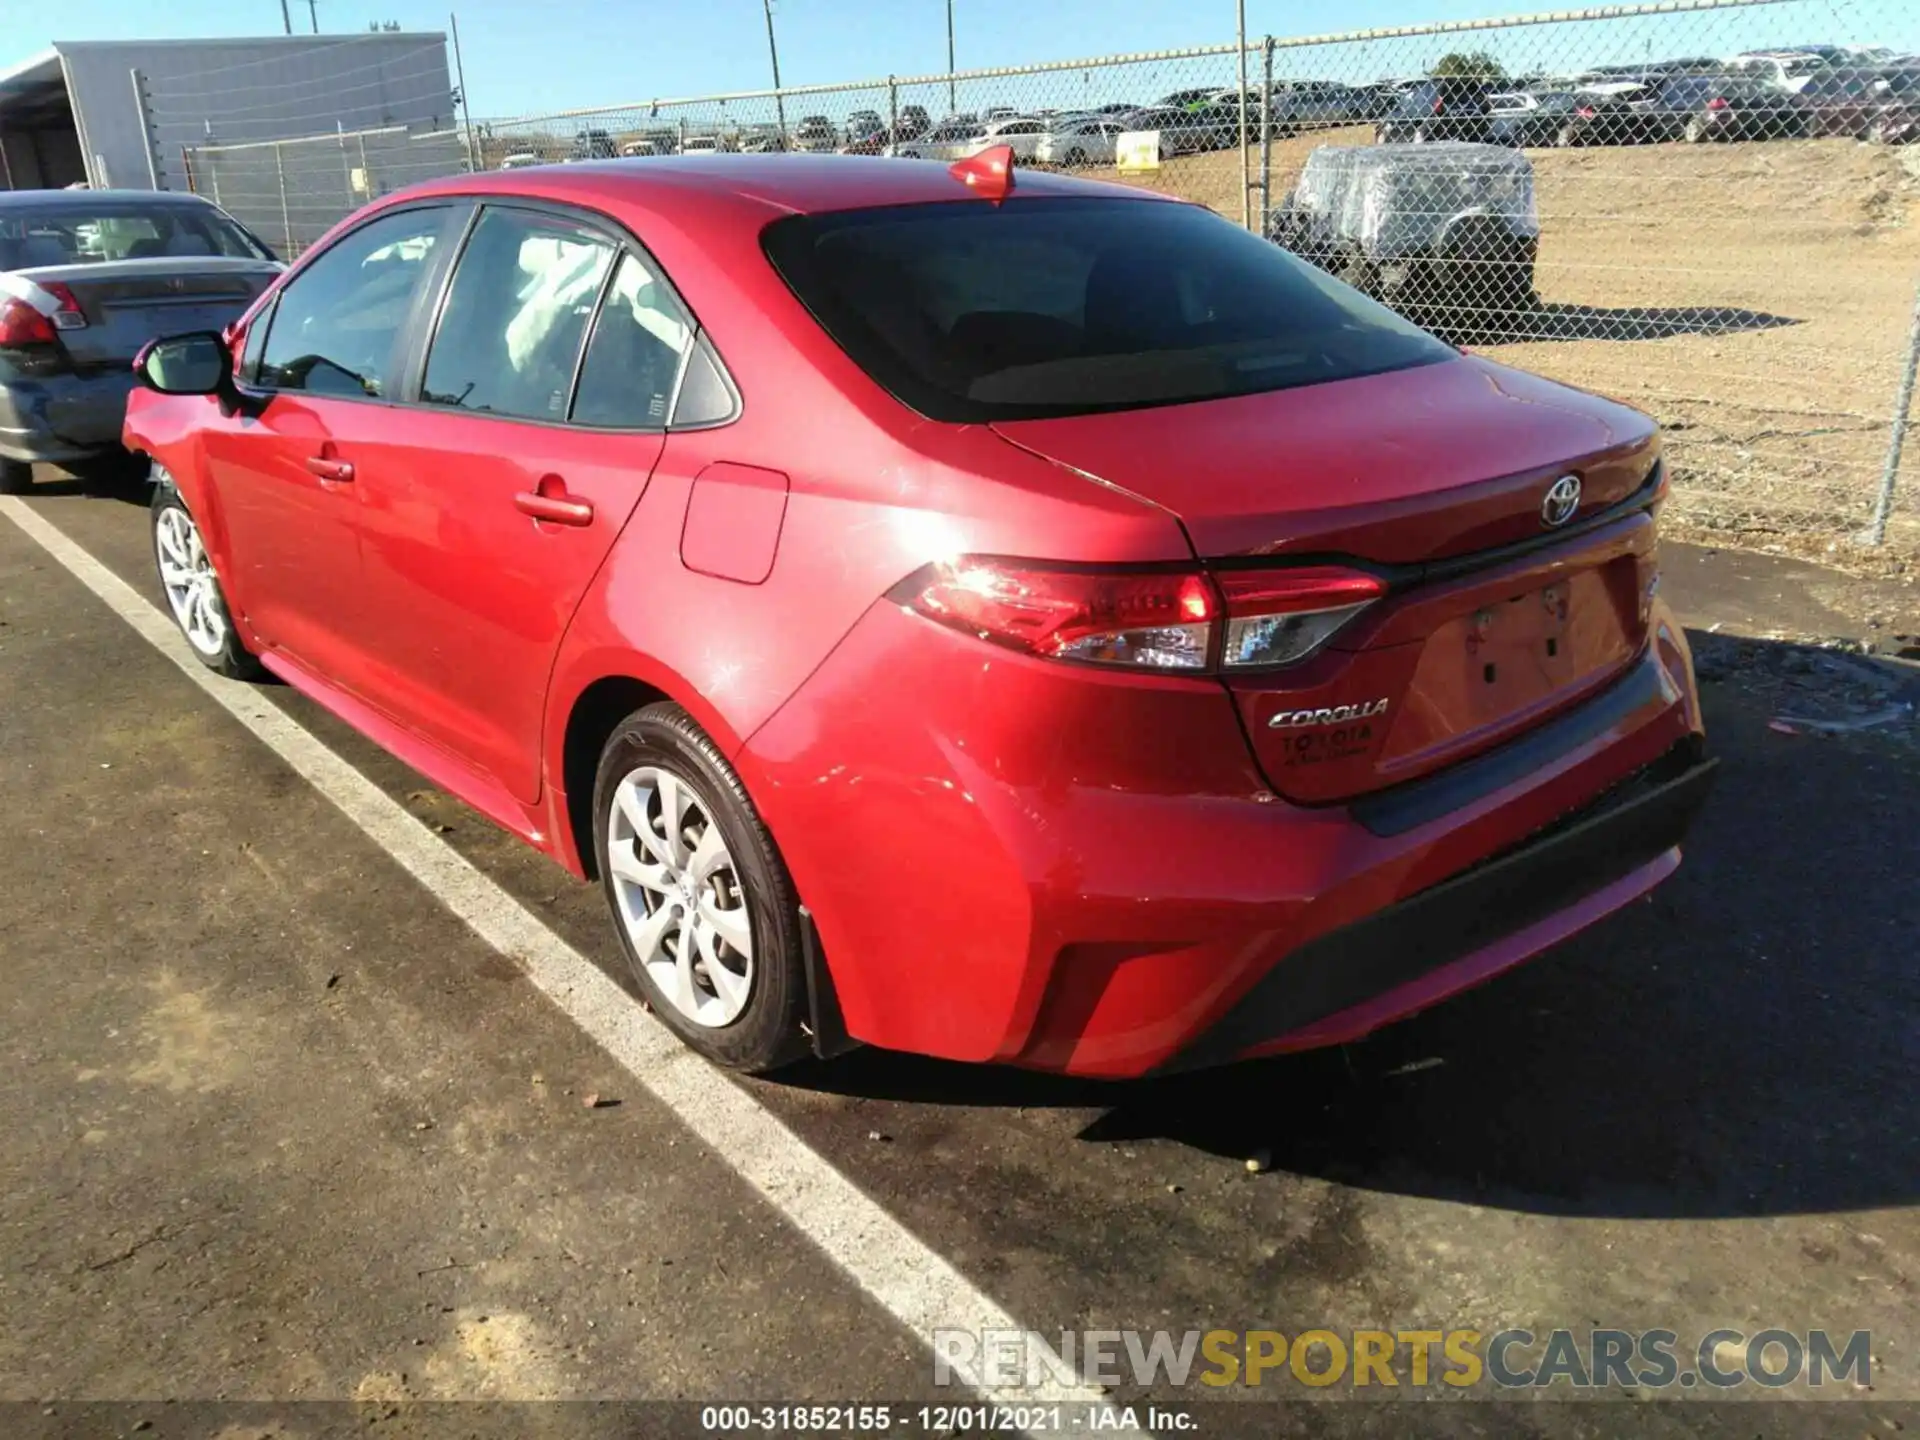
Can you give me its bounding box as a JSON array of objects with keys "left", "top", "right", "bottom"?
[{"left": 891, "top": 555, "right": 1384, "bottom": 672}]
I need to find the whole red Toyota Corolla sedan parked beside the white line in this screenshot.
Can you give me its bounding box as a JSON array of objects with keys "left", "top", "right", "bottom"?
[{"left": 127, "top": 154, "right": 1713, "bottom": 1075}]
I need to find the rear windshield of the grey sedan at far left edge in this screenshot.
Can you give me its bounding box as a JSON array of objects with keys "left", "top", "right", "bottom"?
[{"left": 0, "top": 200, "right": 273, "bottom": 271}]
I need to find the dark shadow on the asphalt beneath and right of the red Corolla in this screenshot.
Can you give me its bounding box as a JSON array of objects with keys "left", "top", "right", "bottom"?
[{"left": 783, "top": 636, "right": 1920, "bottom": 1217}]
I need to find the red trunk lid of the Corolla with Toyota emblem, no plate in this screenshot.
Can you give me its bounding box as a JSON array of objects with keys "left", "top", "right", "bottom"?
[{"left": 995, "top": 357, "right": 1659, "bottom": 803}]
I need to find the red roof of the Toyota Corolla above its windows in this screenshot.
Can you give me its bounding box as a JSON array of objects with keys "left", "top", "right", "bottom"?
[{"left": 386, "top": 154, "right": 1185, "bottom": 215}]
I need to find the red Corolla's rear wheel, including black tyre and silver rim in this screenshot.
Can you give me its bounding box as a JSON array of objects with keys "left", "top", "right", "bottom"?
[{"left": 593, "top": 701, "right": 806, "bottom": 1071}]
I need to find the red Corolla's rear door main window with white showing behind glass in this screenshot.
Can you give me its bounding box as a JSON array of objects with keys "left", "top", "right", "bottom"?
[{"left": 420, "top": 207, "right": 614, "bottom": 420}]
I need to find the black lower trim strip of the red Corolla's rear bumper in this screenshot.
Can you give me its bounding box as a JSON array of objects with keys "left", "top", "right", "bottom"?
[{"left": 1162, "top": 741, "right": 1718, "bottom": 1069}]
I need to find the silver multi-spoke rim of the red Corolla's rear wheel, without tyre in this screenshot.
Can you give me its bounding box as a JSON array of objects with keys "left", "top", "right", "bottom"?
[{"left": 607, "top": 766, "right": 753, "bottom": 1029}]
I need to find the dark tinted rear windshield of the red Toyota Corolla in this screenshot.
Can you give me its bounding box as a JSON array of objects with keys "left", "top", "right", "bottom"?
[{"left": 764, "top": 198, "right": 1455, "bottom": 422}]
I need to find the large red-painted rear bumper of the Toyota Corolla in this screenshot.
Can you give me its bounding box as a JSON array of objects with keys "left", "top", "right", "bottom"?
[{"left": 733, "top": 599, "right": 1703, "bottom": 1077}]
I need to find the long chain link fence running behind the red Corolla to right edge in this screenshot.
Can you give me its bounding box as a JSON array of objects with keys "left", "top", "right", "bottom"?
[{"left": 194, "top": 0, "right": 1920, "bottom": 557}]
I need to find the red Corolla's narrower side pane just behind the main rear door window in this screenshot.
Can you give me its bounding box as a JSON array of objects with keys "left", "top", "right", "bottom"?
[{"left": 574, "top": 253, "right": 693, "bottom": 430}]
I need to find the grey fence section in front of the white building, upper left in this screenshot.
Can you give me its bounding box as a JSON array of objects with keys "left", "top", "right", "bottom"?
[{"left": 180, "top": 125, "right": 468, "bottom": 259}]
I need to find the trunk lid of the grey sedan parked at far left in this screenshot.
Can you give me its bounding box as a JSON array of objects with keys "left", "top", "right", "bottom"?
[{"left": 19, "top": 255, "right": 280, "bottom": 369}]
